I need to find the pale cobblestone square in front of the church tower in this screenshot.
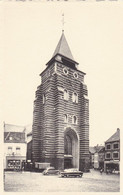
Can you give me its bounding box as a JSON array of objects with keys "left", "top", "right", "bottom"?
[{"left": 4, "top": 170, "right": 120, "bottom": 192}]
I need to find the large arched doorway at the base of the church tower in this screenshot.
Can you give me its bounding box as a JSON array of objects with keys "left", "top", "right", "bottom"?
[{"left": 64, "top": 128, "right": 79, "bottom": 169}]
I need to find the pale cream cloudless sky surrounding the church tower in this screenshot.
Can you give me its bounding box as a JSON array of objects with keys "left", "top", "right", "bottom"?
[{"left": 1, "top": 2, "right": 123, "bottom": 146}]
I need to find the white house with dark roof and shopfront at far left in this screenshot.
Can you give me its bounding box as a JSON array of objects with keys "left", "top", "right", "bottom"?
[{"left": 3, "top": 124, "right": 27, "bottom": 170}]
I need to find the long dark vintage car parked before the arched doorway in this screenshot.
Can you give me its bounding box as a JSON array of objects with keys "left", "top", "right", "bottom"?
[{"left": 60, "top": 169, "right": 83, "bottom": 177}]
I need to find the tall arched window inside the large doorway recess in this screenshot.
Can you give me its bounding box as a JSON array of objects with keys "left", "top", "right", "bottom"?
[{"left": 64, "top": 135, "right": 72, "bottom": 155}]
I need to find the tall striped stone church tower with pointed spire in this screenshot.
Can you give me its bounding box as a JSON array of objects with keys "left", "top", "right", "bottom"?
[{"left": 32, "top": 32, "right": 89, "bottom": 171}]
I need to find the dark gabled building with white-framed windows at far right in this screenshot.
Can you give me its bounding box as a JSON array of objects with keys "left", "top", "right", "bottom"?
[{"left": 104, "top": 128, "right": 120, "bottom": 172}]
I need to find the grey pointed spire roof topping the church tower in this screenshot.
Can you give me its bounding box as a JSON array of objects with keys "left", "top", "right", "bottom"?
[{"left": 53, "top": 32, "right": 74, "bottom": 61}]
